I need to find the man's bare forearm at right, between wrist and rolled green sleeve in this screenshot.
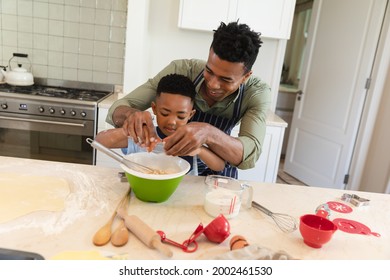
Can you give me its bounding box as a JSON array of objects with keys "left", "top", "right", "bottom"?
[{"left": 206, "top": 127, "right": 244, "bottom": 166}]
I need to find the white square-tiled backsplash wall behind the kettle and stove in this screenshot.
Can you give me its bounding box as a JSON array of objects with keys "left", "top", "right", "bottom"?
[{"left": 0, "top": 0, "right": 127, "bottom": 85}]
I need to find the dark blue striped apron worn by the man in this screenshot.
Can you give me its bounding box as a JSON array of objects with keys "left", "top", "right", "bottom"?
[{"left": 191, "top": 71, "right": 244, "bottom": 179}]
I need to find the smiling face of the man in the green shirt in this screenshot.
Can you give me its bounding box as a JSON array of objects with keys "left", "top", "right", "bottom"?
[{"left": 203, "top": 48, "right": 252, "bottom": 106}]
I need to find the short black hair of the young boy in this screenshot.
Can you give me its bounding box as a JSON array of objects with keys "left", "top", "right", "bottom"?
[{"left": 157, "top": 74, "right": 196, "bottom": 101}]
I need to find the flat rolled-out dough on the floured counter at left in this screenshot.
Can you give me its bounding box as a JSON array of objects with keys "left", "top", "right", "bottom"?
[{"left": 0, "top": 173, "right": 70, "bottom": 223}]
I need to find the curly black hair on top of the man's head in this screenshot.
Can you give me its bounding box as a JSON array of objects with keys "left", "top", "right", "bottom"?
[{"left": 210, "top": 22, "right": 263, "bottom": 72}]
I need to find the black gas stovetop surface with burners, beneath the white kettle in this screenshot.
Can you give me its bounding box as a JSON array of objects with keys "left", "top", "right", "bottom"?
[{"left": 0, "top": 84, "right": 111, "bottom": 102}]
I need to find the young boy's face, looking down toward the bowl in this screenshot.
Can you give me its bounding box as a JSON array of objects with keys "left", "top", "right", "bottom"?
[{"left": 152, "top": 92, "right": 195, "bottom": 136}]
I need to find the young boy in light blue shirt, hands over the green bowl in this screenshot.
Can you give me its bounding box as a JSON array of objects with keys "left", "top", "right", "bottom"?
[{"left": 95, "top": 74, "right": 225, "bottom": 175}]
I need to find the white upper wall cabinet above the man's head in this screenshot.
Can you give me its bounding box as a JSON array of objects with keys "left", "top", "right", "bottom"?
[{"left": 178, "top": 0, "right": 295, "bottom": 39}]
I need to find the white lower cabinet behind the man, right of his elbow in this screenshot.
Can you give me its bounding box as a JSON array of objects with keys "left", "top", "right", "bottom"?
[{"left": 232, "top": 112, "right": 287, "bottom": 183}]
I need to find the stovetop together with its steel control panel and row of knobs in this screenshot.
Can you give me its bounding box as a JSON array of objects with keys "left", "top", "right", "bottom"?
[{"left": 0, "top": 79, "right": 114, "bottom": 120}]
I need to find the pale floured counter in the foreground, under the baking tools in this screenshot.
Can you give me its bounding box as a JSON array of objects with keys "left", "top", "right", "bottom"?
[{"left": 0, "top": 157, "right": 390, "bottom": 259}]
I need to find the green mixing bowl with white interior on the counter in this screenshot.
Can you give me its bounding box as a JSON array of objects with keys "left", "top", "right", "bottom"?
[{"left": 121, "top": 152, "right": 190, "bottom": 202}]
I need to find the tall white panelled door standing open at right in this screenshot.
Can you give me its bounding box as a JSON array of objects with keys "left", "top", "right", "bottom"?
[{"left": 284, "top": 0, "right": 387, "bottom": 189}]
